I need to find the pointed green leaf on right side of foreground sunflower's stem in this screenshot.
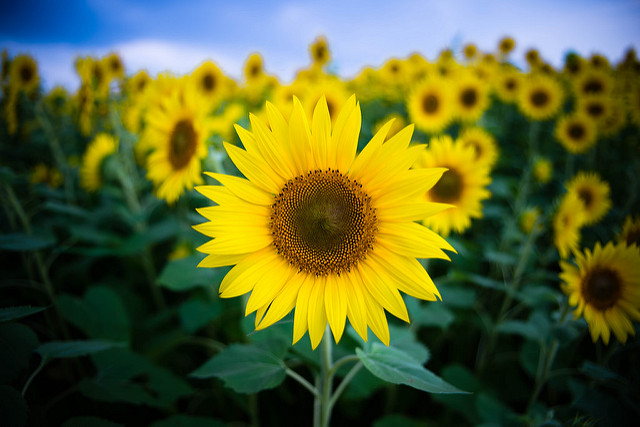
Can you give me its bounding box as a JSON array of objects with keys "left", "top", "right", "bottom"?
[{"left": 356, "top": 343, "right": 466, "bottom": 393}]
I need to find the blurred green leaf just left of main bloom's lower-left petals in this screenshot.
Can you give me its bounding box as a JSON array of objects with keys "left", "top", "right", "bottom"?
[{"left": 157, "top": 254, "right": 229, "bottom": 292}]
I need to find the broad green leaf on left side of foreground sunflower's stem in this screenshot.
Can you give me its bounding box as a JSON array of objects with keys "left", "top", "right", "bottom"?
[{"left": 191, "top": 344, "right": 286, "bottom": 393}]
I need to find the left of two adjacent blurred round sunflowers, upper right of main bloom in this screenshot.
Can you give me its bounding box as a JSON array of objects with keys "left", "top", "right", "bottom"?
[{"left": 407, "top": 77, "right": 454, "bottom": 133}]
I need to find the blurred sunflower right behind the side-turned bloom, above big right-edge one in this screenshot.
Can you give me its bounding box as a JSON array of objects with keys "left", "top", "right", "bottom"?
[{"left": 565, "top": 171, "right": 611, "bottom": 225}]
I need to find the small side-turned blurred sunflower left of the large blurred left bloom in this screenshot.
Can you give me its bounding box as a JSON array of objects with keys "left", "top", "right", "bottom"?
[{"left": 79, "top": 133, "right": 118, "bottom": 192}]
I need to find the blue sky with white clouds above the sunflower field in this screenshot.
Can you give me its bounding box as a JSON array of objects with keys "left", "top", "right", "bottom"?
[{"left": 0, "top": 0, "right": 640, "bottom": 89}]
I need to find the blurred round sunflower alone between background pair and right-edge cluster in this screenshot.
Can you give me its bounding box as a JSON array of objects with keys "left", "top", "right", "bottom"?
[{"left": 518, "top": 73, "right": 563, "bottom": 120}]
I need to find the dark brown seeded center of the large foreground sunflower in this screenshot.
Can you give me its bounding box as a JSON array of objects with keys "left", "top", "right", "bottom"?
[{"left": 269, "top": 169, "right": 378, "bottom": 276}]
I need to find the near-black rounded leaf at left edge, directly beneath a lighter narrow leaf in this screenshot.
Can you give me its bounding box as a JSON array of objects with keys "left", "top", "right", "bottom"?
[{"left": 0, "top": 323, "right": 38, "bottom": 384}]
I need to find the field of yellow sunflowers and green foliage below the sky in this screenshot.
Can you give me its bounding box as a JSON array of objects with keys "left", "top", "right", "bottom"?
[{"left": 0, "top": 36, "right": 640, "bottom": 427}]
